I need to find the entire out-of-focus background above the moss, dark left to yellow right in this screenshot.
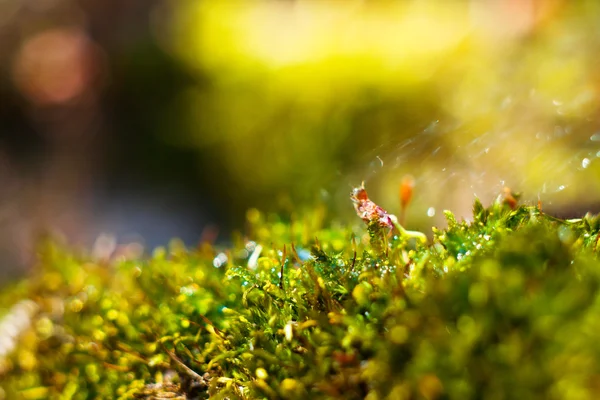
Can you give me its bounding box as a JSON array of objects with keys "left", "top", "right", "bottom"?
[{"left": 0, "top": 0, "right": 600, "bottom": 277}]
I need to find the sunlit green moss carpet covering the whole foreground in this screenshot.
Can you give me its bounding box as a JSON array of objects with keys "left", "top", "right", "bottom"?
[{"left": 0, "top": 201, "right": 600, "bottom": 399}]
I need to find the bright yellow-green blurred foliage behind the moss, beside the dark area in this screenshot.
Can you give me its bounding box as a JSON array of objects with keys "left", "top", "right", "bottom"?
[{"left": 161, "top": 0, "right": 600, "bottom": 219}]
